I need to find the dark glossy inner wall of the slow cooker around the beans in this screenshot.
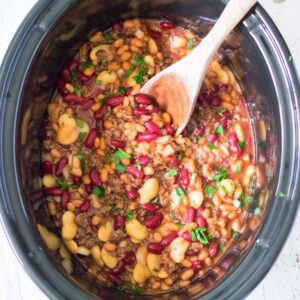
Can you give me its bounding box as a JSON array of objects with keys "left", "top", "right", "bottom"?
[{"left": 16, "top": 0, "right": 279, "bottom": 299}]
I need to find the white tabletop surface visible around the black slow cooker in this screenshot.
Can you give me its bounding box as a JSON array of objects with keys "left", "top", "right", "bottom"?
[{"left": 0, "top": 0, "right": 300, "bottom": 300}]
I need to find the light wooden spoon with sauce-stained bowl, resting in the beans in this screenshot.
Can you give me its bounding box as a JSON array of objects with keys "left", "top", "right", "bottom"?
[{"left": 141, "top": 0, "right": 258, "bottom": 135}]
